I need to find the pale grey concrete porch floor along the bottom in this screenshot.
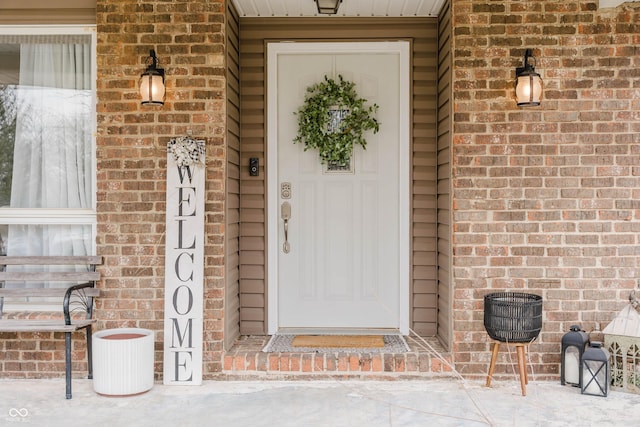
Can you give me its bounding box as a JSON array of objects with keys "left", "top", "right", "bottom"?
[{"left": 0, "top": 378, "right": 639, "bottom": 427}]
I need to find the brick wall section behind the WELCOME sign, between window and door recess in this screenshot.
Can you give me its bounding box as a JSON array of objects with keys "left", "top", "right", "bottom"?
[{"left": 97, "top": 0, "right": 226, "bottom": 375}]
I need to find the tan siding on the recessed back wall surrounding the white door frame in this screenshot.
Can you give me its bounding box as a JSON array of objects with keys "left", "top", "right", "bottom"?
[{"left": 240, "top": 18, "right": 438, "bottom": 335}]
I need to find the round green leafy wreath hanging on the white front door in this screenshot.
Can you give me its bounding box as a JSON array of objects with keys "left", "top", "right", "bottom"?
[{"left": 293, "top": 75, "right": 380, "bottom": 165}]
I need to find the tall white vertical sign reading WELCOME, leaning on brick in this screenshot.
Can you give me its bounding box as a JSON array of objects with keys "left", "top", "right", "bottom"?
[{"left": 163, "top": 137, "right": 205, "bottom": 385}]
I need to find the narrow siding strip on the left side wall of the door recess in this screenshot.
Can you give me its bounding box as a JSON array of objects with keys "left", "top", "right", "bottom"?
[{"left": 224, "top": 2, "right": 241, "bottom": 349}]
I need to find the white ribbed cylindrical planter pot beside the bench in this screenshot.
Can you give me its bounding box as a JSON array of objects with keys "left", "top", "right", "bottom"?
[{"left": 92, "top": 328, "right": 154, "bottom": 396}]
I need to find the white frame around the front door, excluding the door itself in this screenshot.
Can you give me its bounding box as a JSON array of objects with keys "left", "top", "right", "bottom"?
[{"left": 266, "top": 41, "right": 411, "bottom": 335}]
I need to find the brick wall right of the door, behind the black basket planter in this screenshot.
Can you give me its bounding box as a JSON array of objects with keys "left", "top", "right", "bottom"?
[{"left": 453, "top": 0, "right": 640, "bottom": 378}]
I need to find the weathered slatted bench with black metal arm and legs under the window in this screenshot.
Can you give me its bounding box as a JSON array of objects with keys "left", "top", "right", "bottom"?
[{"left": 0, "top": 256, "right": 102, "bottom": 399}]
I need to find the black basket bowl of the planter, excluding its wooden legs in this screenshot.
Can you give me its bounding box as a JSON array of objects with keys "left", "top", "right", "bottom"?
[{"left": 484, "top": 292, "right": 542, "bottom": 343}]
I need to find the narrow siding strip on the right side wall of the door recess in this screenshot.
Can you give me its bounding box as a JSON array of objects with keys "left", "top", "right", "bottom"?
[{"left": 437, "top": 1, "right": 453, "bottom": 352}]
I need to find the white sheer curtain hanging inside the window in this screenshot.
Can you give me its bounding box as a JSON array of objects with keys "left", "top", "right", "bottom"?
[{"left": 7, "top": 43, "right": 92, "bottom": 255}]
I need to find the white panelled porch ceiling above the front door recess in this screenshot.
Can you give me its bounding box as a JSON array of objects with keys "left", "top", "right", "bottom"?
[{"left": 232, "top": 0, "right": 445, "bottom": 18}]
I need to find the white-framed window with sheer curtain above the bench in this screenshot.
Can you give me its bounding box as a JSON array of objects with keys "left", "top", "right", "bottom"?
[{"left": 0, "top": 26, "right": 96, "bottom": 287}]
